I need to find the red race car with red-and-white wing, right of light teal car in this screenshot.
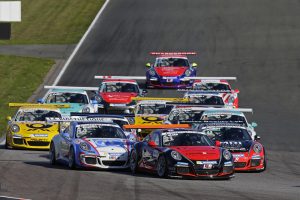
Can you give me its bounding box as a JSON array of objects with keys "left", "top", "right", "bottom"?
[{"left": 94, "top": 76, "right": 147, "bottom": 114}]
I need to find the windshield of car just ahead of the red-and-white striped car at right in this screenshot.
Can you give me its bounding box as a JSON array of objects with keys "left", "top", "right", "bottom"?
[{"left": 186, "top": 94, "right": 224, "bottom": 105}]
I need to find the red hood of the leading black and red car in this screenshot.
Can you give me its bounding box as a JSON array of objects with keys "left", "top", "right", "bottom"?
[{"left": 170, "top": 146, "right": 220, "bottom": 160}]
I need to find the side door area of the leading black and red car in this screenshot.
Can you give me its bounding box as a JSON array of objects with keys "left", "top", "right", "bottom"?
[{"left": 142, "top": 132, "right": 160, "bottom": 170}]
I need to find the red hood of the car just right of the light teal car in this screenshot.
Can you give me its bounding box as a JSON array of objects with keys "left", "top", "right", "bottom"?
[{"left": 100, "top": 92, "right": 138, "bottom": 104}]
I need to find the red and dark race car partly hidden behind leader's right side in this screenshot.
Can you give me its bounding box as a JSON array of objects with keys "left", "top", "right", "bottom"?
[{"left": 197, "top": 122, "right": 267, "bottom": 172}]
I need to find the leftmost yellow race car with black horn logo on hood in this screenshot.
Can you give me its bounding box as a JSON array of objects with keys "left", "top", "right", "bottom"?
[{"left": 5, "top": 103, "right": 68, "bottom": 149}]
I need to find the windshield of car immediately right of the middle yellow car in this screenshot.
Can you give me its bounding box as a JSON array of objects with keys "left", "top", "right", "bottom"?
[{"left": 168, "top": 109, "right": 203, "bottom": 124}]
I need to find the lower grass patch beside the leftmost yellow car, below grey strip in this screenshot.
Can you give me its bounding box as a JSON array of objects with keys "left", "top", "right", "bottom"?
[{"left": 0, "top": 56, "right": 54, "bottom": 136}]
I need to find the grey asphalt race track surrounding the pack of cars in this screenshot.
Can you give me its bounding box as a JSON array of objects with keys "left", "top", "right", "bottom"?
[{"left": 0, "top": 0, "right": 300, "bottom": 200}]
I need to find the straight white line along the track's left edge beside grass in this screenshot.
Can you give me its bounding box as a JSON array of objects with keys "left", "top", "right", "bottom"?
[{"left": 53, "top": 0, "right": 110, "bottom": 85}]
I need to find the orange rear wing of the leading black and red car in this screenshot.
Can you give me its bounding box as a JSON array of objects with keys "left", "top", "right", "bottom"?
[{"left": 123, "top": 124, "right": 191, "bottom": 129}]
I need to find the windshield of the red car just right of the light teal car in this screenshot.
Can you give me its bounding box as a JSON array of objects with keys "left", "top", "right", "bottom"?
[{"left": 100, "top": 82, "right": 139, "bottom": 93}]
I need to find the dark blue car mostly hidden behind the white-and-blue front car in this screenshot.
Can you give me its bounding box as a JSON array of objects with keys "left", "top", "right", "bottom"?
[{"left": 71, "top": 113, "right": 137, "bottom": 141}]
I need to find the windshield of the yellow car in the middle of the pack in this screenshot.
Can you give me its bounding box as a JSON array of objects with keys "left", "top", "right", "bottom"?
[{"left": 137, "top": 104, "right": 174, "bottom": 115}]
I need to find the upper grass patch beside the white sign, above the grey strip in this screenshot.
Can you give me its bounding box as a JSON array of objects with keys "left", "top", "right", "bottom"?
[{"left": 0, "top": 0, "right": 105, "bottom": 44}]
